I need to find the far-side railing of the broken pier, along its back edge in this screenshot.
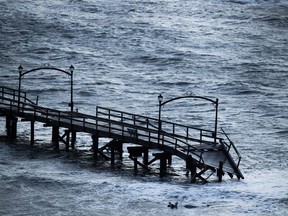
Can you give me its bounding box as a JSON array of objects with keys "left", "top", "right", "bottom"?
[{"left": 0, "top": 87, "right": 215, "bottom": 148}]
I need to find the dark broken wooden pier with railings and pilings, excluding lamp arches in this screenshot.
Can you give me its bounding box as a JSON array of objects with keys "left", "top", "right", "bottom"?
[{"left": 0, "top": 87, "right": 244, "bottom": 182}]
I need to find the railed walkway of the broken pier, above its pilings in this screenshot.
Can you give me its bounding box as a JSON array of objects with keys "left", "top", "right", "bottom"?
[{"left": 0, "top": 87, "right": 242, "bottom": 179}]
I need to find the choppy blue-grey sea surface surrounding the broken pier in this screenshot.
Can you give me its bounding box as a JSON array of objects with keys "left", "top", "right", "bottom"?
[{"left": 0, "top": 0, "right": 288, "bottom": 216}]
